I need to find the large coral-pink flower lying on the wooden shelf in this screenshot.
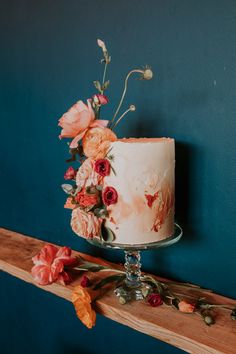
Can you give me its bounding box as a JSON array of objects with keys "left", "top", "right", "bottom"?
[{"left": 31, "top": 245, "right": 76, "bottom": 285}]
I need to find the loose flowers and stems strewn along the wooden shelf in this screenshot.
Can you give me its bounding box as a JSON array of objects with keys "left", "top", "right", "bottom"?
[{"left": 31, "top": 244, "right": 236, "bottom": 328}]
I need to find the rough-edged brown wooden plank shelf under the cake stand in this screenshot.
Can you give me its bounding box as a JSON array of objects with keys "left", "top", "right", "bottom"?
[{"left": 0, "top": 228, "right": 236, "bottom": 354}]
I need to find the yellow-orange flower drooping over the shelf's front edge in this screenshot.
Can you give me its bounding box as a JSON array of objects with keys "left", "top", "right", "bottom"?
[{"left": 71, "top": 285, "right": 96, "bottom": 329}]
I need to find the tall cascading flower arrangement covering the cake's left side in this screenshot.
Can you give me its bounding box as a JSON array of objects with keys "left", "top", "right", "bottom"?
[{"left": 59, "top": 39, "right": 153, "bottom": 241}]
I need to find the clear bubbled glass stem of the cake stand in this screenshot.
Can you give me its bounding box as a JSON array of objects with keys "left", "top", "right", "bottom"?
[{"left": 124, "top": 251, "right": 141, "bottom": 288}]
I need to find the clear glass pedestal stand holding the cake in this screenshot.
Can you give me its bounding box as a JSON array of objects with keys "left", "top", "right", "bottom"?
[{"left": 88, "top": 223, "right": 183, "bottom": 302}]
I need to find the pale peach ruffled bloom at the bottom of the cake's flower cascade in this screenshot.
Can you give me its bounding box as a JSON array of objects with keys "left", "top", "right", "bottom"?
[{"left": 71, "top": 208, "right": 102, "bottom": 238}]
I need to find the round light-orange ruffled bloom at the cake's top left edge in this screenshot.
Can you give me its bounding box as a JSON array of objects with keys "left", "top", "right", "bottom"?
[{"left": 82, "top": 127, "right": 117, "bottom": 160}]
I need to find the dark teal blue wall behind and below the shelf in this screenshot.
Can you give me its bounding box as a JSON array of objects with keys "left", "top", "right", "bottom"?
[{"left": 0, "top": 0, "right": 236, "bottom": 354}]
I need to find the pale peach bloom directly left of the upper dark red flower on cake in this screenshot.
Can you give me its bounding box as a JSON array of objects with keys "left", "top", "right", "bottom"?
[{"left": 76, "top": 159, "right": 102, "bottom": 188}]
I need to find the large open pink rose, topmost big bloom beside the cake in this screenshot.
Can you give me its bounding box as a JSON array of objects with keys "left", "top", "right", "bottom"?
[{"left": 58, "top": 100, "right": 108, "bottom": 148}]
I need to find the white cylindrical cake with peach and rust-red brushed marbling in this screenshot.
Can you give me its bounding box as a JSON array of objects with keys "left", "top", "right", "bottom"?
[{"left": 103, "top": 138, "right": 175, "bottom": 244}]
